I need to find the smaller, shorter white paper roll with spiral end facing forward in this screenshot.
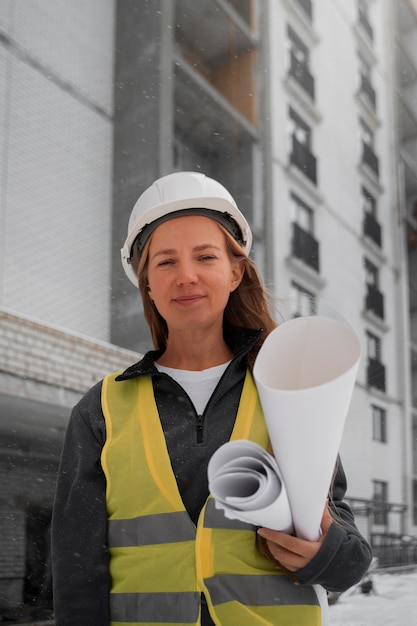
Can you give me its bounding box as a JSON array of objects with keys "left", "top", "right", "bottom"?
[{"left": 208, "top": 440, "right": 293, "bottom": 532}]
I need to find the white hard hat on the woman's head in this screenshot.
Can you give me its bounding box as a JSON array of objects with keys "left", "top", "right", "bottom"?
[{"left": 121, "top": 172, "right": 252, "bottom": 286}]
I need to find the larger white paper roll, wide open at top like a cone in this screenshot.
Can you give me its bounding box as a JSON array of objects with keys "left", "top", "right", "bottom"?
[{"left": 253, "top": 316, "right": 360, "bottom": 541}]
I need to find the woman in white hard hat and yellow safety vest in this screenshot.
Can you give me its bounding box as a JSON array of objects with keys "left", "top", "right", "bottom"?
[{"left": 52, "top": 172, "right": 371, "bottom": 626}]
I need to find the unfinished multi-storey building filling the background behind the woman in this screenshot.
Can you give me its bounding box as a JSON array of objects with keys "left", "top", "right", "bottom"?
[{"left": 0, "top": 0, "right": 417, "bottom": 619}]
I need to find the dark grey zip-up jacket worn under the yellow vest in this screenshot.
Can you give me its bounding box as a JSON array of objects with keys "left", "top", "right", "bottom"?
[{"left": 52, "top": 329, "right": 371, "bottom": 626}]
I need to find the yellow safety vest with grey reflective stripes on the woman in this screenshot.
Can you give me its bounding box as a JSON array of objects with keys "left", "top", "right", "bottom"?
[{"left": 101, "top": 371, "right": 321, "bottom": 626}]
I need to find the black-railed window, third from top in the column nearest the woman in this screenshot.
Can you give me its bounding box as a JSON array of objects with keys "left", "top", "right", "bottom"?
[{"left": 291, "top": 194, "right": 319, "bottom": 272}]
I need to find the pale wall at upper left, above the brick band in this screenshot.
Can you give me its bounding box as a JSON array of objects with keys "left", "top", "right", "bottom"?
[{"left": 0, "top": 0, "right": 114, "bottom": 340}]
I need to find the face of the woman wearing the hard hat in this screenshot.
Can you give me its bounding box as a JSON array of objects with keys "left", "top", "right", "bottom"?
[{"left": 148, "top": 215, "right": 244, "bottom": 332}]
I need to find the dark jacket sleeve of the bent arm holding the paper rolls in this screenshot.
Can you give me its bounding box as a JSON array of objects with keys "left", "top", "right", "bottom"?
[{"left": 296, "top": 460, "right": 372, "bottom": 591}]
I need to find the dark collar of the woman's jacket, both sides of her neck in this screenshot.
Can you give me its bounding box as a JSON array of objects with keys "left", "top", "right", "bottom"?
[{"left": 116, "top": 327, "right": 262, "bottom": 380}]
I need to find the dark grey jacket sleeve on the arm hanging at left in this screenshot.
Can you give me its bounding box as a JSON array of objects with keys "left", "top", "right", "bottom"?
[{"left": 52, "top": 384, "right": 110, "bottom": 626}]
